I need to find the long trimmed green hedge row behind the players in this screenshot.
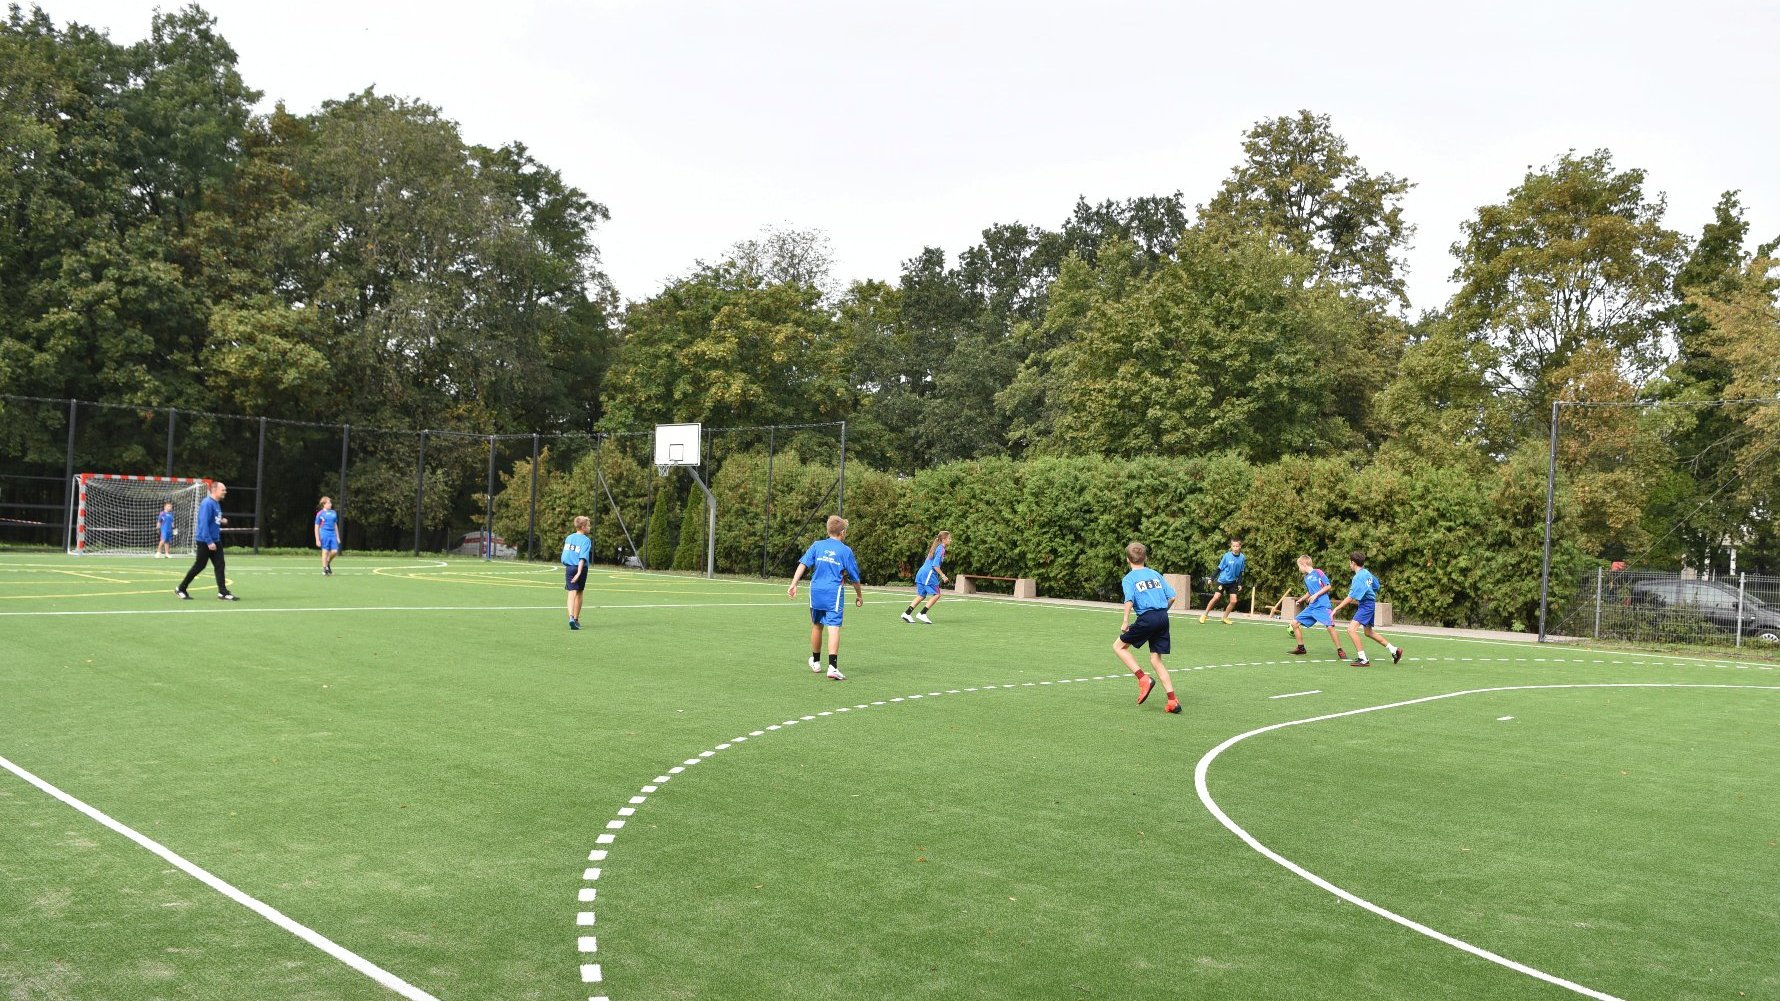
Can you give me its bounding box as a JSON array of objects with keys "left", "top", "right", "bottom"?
[{"left": 497, "top": 443, "right": 1591, "bottom": 629}]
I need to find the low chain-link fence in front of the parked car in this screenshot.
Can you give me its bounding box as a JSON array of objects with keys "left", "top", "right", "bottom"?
[{"left": 1559, "top": 568, "right": 1780, "bottom": 650}]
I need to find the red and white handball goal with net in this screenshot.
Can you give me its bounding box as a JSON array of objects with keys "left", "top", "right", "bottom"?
[{"left": 68, "top": 472, "right": 210, "bottom": 556}]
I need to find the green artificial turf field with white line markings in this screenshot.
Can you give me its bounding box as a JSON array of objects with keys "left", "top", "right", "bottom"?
[{"left": 0, "top": 552, "right": 1780, "bottom": 1001}]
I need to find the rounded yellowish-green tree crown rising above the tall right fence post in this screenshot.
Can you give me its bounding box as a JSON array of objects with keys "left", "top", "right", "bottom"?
[{"left": 1451, "top": 150, "right": 1686, "bottom": 413}]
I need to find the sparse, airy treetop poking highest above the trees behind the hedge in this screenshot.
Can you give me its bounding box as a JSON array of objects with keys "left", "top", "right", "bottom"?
[{"left": 1200, "top": 110, "right": 1413, "bottom": 306}]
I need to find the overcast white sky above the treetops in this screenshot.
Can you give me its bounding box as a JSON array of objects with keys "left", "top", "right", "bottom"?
[{"left": 43, "top": 0, "right": 1780, "bottom": 310}]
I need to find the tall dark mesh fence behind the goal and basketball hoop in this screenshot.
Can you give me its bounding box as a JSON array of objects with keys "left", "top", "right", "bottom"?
[{"left": 0, "top": 395, "right": 846, "bottom": 575}]
